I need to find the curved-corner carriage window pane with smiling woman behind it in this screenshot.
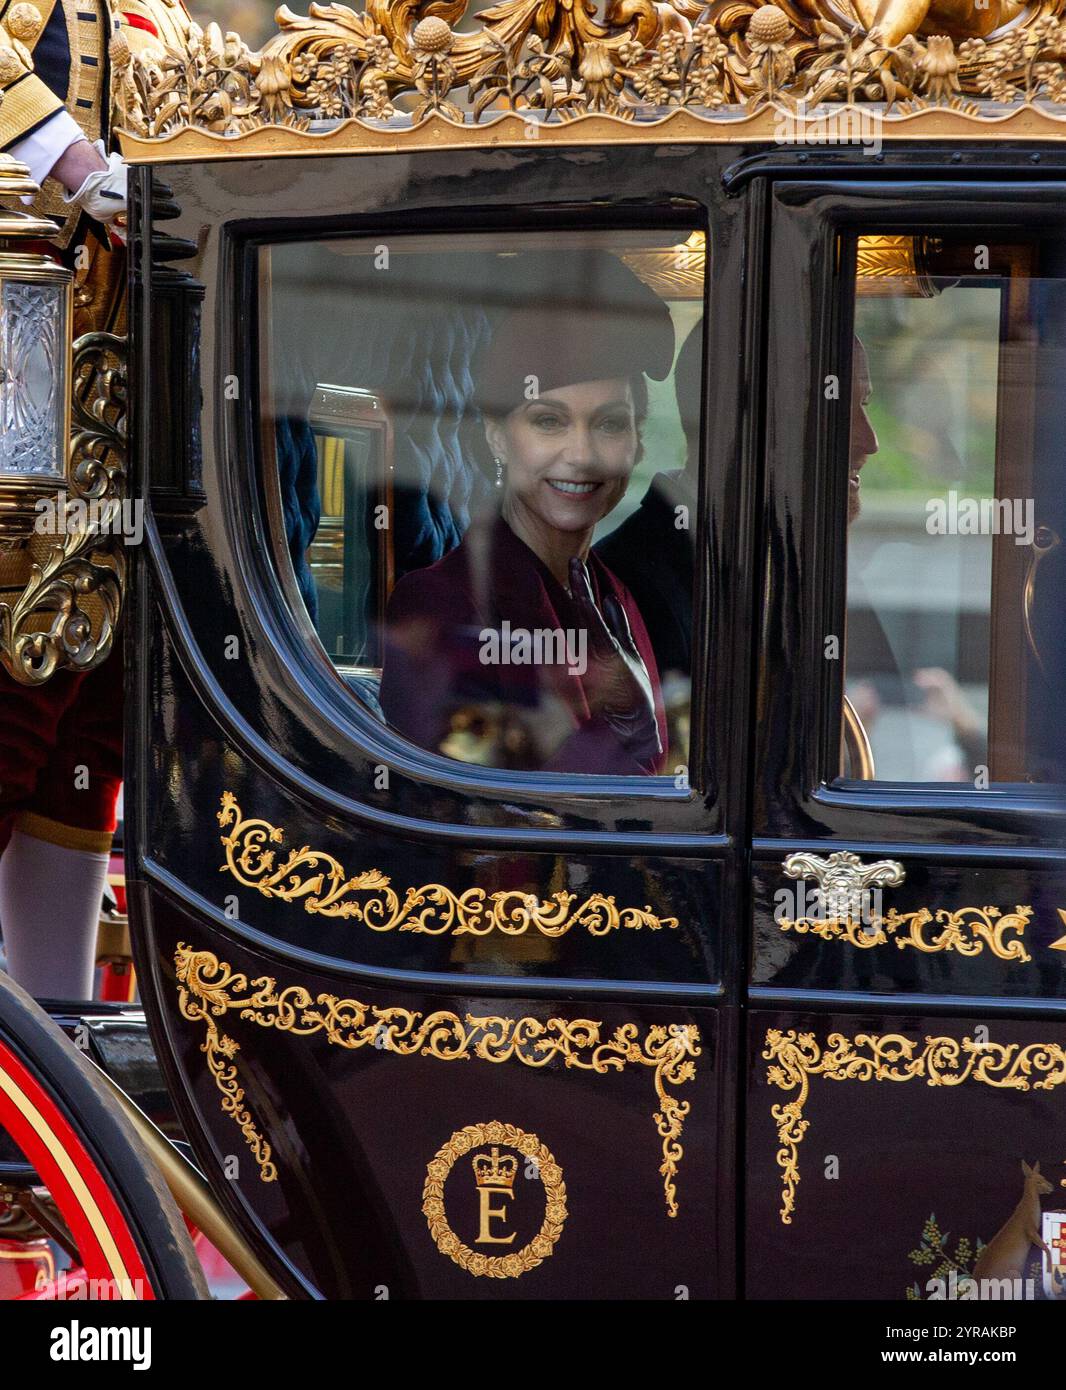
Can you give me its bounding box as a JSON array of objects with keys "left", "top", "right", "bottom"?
[{"left": 260, "top": 228, "right": 705, "bottom": 776}]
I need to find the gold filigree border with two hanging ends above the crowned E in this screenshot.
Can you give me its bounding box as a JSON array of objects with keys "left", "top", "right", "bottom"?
[{"left": 174, "top": 942, "right": 702, "bottom": 1216}]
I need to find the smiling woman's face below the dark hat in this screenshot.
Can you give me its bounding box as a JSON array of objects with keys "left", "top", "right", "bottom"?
[{"left": 485, "top": 379, "right": 639, "bottom": 531}]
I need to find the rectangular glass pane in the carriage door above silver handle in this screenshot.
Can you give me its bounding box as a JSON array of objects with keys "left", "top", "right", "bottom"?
[{"left": 844, "top": 234, "right": 1066, "bottom": 788}]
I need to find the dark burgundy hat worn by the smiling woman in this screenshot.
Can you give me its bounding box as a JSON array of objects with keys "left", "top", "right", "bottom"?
[{"left": 475, "top": 250, "right": 674, "bottom": 416}]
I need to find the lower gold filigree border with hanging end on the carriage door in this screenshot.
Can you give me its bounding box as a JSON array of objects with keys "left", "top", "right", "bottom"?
[{"left": 763, "top": 1029, "right": 1066, "bottom": 1226}]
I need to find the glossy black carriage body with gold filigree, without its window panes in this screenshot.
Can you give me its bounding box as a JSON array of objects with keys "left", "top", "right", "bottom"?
[{"left": 120, "top": 62, "right": 1066, "bottom": 1298}]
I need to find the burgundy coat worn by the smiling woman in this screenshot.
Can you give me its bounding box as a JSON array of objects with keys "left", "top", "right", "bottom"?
[{"left": 381, "top": 518, "right": 667, "bottom": 776}]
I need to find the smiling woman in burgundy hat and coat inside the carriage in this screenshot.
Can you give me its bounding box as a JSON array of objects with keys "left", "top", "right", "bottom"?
[{"left": 381, "top": 250, "right": 674, "bottom": 774}]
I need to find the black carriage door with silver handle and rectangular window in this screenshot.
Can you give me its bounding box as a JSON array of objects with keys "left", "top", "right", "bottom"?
[{"left": 746, "top": 182, "right": 1066, "bottom": 1298}]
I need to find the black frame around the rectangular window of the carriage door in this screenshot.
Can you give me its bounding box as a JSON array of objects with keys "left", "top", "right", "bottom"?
[{"left": 812, "top": 215, "right": 1066, "bottom": 810}]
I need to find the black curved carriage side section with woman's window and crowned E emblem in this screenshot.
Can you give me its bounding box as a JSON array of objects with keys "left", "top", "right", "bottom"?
[{"left": 131, "top": 146, "right": 751, "bottom": 1301}]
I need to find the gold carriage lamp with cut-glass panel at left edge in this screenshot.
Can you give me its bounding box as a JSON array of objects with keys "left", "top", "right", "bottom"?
[{"left": 0, "top": 154, "right": 74, "bottom": 525}]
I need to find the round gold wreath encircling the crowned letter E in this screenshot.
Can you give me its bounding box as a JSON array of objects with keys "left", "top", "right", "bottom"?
[{"left": 423, "top": 1120, "right": 566, "bottom": 1279}]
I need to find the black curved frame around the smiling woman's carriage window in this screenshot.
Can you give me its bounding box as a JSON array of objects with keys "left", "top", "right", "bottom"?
[{"left": 244, "top": 199, "right": 721, "bottom": 806}]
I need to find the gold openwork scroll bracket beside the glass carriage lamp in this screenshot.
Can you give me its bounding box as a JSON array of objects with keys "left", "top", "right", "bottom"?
[{"left": 0, "top": 332, "right": 126, "bottom": 685}]
